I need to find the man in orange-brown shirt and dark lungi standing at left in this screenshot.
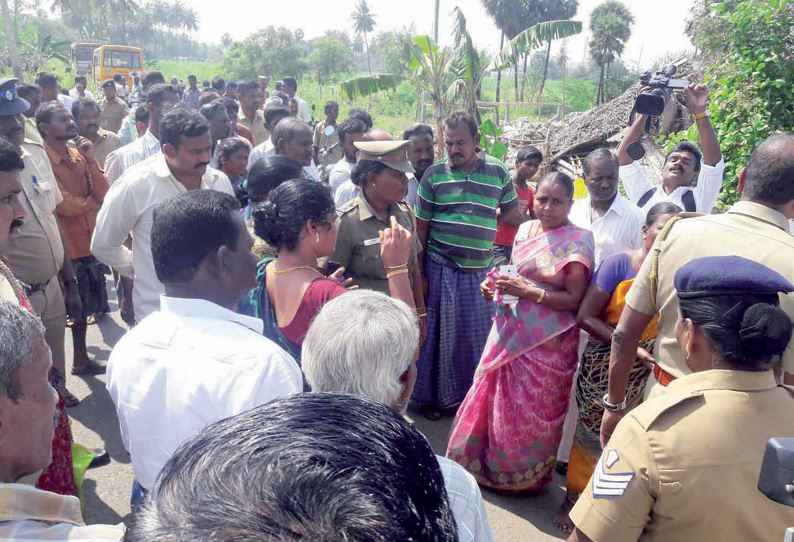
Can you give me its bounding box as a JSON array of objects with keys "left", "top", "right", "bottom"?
[{"left": 36, "top": 102, "right": 110, "bottom": 374}]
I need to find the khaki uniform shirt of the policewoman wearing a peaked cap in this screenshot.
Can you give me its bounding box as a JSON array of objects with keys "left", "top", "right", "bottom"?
[{"left": 328, "top": 195, "right": 422, "bottom": 294}]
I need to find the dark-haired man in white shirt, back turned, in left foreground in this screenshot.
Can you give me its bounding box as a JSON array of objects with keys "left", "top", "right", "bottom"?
[{"left": 107, "top": 190, "right": 303, "bottom": 490}]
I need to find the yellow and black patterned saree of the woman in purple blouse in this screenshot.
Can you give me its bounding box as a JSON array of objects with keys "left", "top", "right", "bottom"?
[{"left": 565, "top": 278, "right": 658, "bottom": 495}]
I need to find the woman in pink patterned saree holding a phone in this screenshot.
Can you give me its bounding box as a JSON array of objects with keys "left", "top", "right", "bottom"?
[{"left": 446, "top": 173, "right": 594, "bottom": 491}]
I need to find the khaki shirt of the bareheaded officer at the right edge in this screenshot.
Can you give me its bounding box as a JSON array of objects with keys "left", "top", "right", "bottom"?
[{"left": 626, "top": 201, "right": 794, "bottom": 396}]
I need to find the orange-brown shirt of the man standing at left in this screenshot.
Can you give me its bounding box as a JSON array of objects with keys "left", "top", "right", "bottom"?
[{"left": 44, "top": 143, "right": 108, "bottom": 260}]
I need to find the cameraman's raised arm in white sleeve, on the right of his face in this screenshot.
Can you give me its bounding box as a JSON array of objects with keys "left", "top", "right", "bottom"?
[{"left": 684, "top": 84, "right": 725, "bottom": 214}]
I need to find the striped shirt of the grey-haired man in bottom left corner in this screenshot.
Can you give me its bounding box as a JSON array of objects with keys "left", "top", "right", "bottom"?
[{"left": 0, "top": 484, "right": 124, "bottom": 542}]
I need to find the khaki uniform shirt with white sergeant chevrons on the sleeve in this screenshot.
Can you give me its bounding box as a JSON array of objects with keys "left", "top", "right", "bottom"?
[{"left": 571, "top": 370, "right": 794, "bottom": 542}]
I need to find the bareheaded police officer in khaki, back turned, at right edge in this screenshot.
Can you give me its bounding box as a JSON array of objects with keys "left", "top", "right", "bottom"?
[{"left": 601, "top": 132, "right": 794, "bottom": 445}]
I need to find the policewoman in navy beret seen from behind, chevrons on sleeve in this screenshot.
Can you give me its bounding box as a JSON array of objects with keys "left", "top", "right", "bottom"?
[{"left": 568, "top": 256, "right": 794, "bottom": 542}]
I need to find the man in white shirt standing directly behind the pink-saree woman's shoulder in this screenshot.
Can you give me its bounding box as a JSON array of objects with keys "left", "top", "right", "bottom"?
[{"left": 568, "top": 149, "right": 645, "bottom": 265}]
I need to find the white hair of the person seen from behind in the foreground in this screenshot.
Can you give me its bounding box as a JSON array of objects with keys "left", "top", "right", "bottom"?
[{"left": 301, "top": 290, "right": 419, "bottom": 406}]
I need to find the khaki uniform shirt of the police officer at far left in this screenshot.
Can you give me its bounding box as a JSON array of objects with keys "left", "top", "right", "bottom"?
[{"left": 5, "top": 142, "right": 64, "bottom": 286}]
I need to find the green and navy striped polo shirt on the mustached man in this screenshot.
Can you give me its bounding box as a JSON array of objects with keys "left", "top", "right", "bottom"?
[{"left": 414, "top": 156, "right": 518, "bottom": 270}]
